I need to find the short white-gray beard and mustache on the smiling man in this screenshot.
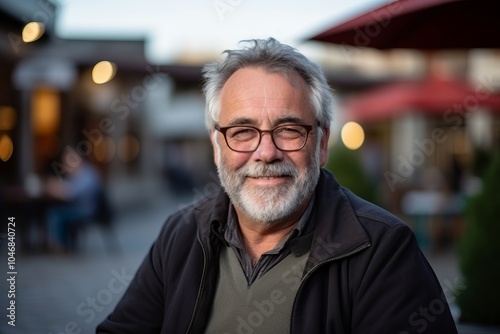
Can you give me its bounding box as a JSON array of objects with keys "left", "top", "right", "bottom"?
[{"left": 218, "top": 137, "right": 320, "bottom": 227}]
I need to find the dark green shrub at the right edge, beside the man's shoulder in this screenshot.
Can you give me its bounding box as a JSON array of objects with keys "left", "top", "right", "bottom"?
[{"left": 457, "top": 154, "right": 500, "bottom": 324}]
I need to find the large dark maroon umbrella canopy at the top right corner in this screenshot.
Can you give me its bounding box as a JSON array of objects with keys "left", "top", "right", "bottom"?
[{"left": 311, "top": 0, "right": 500, "bottom": 49}]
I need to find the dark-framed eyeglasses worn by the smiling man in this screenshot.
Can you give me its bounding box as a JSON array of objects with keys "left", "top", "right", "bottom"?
[{"left": 215, "top": 124, "right": 313, "bottom": 152}]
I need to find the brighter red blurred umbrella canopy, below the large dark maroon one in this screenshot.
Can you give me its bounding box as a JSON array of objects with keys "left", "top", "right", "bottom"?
[{"left": 343, "top": 77, "right": 500, "bottom": 121}]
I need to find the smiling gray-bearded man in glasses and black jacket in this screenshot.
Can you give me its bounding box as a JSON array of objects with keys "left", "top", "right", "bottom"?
[{"left": 97, "top": 39, "right": 456, "bottom": 334}]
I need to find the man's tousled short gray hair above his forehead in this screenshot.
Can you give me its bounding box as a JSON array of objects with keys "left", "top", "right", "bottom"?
[{"left": 203, "top": 38, "right": 333, "bottom": 130}]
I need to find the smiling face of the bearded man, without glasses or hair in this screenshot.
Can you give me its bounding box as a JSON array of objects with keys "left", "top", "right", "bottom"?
[{"left": 211, "top": 67, "right": 329, "bottom": 226}]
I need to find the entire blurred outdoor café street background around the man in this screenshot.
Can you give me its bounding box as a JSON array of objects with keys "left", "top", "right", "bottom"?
[{"left": 0, "top": 0, "right": 500, "bottom": 334}]
